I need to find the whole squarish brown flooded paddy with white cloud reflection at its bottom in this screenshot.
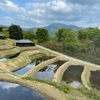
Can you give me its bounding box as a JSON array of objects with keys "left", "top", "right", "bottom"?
[{"left": 62, "top": 66, "right": 84, "bottom": 88}]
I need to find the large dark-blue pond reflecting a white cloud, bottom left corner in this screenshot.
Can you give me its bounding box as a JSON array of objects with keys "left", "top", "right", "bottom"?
[{"left": 0, "top": 82, "right": 48, "bottom": 100}]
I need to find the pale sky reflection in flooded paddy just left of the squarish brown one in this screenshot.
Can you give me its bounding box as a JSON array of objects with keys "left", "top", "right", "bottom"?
[{"left": 35, "top": 64, "right": 57, "bottom": 80}]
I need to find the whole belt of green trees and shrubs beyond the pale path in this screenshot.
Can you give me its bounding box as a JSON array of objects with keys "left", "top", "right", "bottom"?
[{"left": 2, "top": 25, "right": 100, "bottom": 64}]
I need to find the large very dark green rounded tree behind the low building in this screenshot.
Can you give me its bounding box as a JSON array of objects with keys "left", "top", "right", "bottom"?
[{"left": 9, "top": 25, "right": 23, "bottom": 40}]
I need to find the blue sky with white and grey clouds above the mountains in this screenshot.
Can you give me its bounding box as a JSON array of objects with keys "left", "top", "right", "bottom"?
[{"left": 0, "top": 0, "right": 100, "bottom": 27}]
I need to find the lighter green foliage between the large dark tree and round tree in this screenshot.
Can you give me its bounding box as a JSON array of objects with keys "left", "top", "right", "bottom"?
[{"left": 23, "top": 30, "right": 35, "bottom": 41}]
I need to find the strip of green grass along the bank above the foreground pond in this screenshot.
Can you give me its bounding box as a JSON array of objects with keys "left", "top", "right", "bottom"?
[{"left": 23, "top": 77, "right": 100, "bottom": 100}]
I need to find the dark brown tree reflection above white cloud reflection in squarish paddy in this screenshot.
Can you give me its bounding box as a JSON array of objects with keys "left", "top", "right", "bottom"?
[{"left": 62, "top": 66, "right": 84, "bottom": 83}]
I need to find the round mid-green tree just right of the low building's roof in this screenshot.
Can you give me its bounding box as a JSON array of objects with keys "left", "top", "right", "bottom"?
[{"left": 36, "top": 28, "right": 49, "bottom": 43}]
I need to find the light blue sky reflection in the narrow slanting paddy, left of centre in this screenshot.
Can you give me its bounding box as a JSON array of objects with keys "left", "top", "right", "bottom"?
[{"left": 15, "top": 62, "right": 35, "bottom": 75}]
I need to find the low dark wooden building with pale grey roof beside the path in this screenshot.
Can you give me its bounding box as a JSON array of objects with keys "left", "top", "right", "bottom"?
[{"left": 16, "top": 39, "right": 35, "bottom": 47}]
